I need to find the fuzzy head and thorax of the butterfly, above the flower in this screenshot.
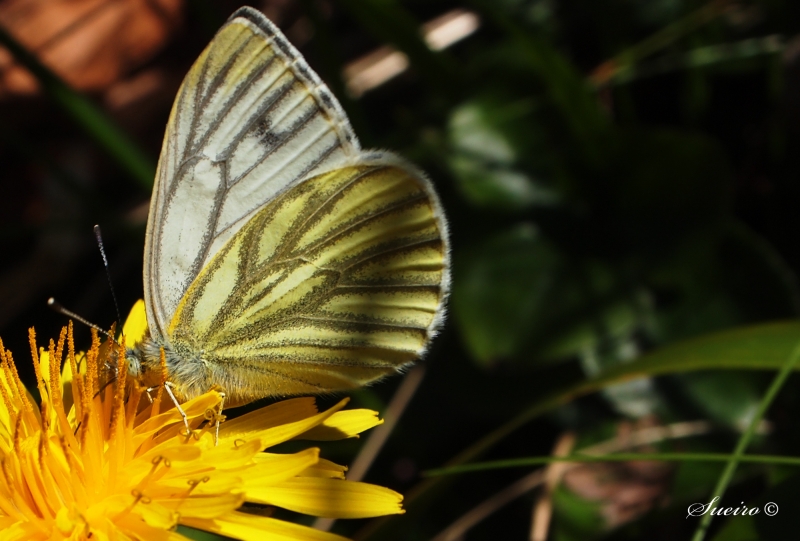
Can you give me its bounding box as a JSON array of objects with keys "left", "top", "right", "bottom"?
[{"left": 125, "top": 332, "right": 212, "bottom": 400}]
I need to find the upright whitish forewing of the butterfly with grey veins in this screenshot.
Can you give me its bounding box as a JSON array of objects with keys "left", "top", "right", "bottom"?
[{"left": 144, "top": 8, "right": 359, "bottom": 338}]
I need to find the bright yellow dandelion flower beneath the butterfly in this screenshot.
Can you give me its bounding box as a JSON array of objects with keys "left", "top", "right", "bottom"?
[{"left": 0, "top": 302, "right": 403, "bottom": 541}]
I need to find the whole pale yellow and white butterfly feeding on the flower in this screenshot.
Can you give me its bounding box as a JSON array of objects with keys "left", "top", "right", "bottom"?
[{"left": 126, "top": 7, "right": 449, "bottom": 405}]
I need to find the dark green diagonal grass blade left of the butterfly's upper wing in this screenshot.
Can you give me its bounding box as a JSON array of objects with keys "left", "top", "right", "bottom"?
[{"left": 0, "top": 27, "right": 156, "bottom": 190}]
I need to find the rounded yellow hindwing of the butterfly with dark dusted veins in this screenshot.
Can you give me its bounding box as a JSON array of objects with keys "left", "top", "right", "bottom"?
[{"left": 169, "top": 160, "right": 448, "bottom": 402}]
